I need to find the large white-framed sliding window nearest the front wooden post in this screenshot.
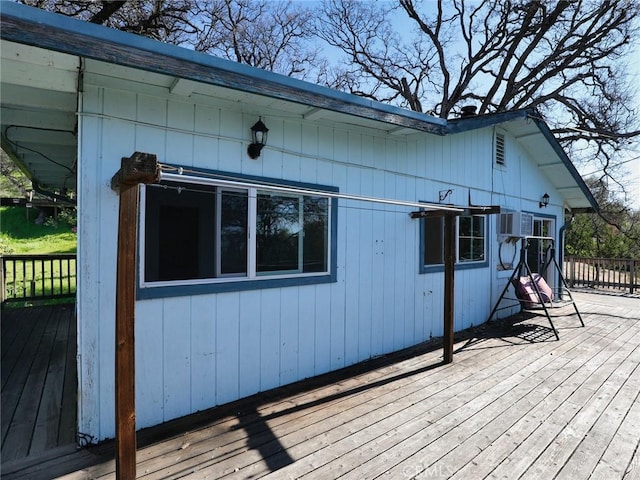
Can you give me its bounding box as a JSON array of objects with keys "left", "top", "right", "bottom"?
[{"left": 139, "top": 177, "right": 336, "bottom": 298}]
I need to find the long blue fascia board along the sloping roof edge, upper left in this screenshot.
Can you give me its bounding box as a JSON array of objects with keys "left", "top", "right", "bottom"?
[{"left": 0, "top": 1, "right": 447, "bottom": 135}]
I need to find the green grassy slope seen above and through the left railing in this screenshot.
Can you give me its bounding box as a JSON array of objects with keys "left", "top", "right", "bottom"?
[{"left": 0, "top": 207, "right": 77, "bottom": 307}]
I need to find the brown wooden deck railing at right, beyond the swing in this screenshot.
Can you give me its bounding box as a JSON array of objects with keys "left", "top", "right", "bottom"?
[{"left": 564, "top": 256, "right": 640, "bottom": 293}]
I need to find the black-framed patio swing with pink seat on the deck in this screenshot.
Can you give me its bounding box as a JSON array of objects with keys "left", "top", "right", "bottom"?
[{"left": 487, "top": 236, "right": 584, "bottom": 340}]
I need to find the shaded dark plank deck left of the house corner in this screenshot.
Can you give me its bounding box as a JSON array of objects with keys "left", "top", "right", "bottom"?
[{"left": 0, "top": 305, "right": 77, "bottom": 464}]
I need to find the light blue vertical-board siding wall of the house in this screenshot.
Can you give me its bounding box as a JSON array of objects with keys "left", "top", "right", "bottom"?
[{"left": 78, "top": 79, "right": 559, "bottom": 440}]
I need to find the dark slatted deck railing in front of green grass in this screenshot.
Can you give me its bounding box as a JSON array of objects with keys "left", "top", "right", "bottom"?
[{"left": 0, "top": 254, "right": 76, "bottom": 303}]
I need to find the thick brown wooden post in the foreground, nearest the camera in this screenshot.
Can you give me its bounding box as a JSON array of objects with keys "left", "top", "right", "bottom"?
[{"left": 111, "top": 152, "right": 160, "bottom": 480}]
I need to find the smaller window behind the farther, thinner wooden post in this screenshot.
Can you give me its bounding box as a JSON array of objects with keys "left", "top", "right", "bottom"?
[{"left": 421, "top": 215, "right": 487, "bottom": 273}]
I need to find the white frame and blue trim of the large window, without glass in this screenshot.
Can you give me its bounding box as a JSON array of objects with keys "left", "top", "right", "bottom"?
[{"left": 136, "top": 167, "right": 338, "bottom": 299}]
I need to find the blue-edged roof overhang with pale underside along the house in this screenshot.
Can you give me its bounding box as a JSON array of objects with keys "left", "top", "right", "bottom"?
[{"left": 0, "top": 0, "right": 597, "bottom": 209}]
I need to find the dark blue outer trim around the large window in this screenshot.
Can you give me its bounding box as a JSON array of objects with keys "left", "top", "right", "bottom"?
[{"left": 136, "top": 165, "right": 339, "bottom": 300}]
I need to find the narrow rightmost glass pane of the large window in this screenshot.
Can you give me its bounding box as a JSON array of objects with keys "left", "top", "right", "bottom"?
[{"left": 303, "top": 197, "right": 329, "bottom": 272}]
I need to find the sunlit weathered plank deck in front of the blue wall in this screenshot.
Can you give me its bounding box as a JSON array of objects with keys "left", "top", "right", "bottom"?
[{"left": 3, "top": 293, "right": 640, "bottom": 480}]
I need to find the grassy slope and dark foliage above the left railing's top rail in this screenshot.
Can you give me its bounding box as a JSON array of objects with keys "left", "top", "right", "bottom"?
[{"left": 0, "top": 207, "right": 77, "bottom": 255}]
